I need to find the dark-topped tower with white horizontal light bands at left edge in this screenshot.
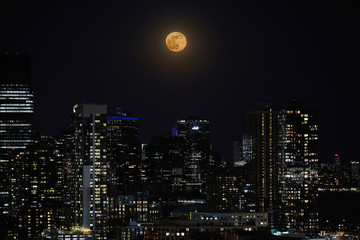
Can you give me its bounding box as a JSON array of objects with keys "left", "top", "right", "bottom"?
[{"left": 0, "top": 54, "right": 34, "bottom": 149}]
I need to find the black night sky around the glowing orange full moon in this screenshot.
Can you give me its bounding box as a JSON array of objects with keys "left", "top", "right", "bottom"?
[{"left": 0, "top": 0, "right": 360, "bottom": 161}]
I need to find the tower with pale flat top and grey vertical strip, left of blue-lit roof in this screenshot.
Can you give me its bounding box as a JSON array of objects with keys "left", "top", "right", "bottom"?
[{"left": 72, "top": 104, "right": 108, "bottom": 239}]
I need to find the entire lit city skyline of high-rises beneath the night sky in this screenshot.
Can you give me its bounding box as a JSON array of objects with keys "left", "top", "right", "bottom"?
[{"left": 0, "top": 54, "right": 360, "bottom": 240}]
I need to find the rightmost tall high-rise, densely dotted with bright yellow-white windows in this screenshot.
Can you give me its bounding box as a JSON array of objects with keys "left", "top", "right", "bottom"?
[{"left": 279, "top": 100, "right": 319, "bottom": 235}]
